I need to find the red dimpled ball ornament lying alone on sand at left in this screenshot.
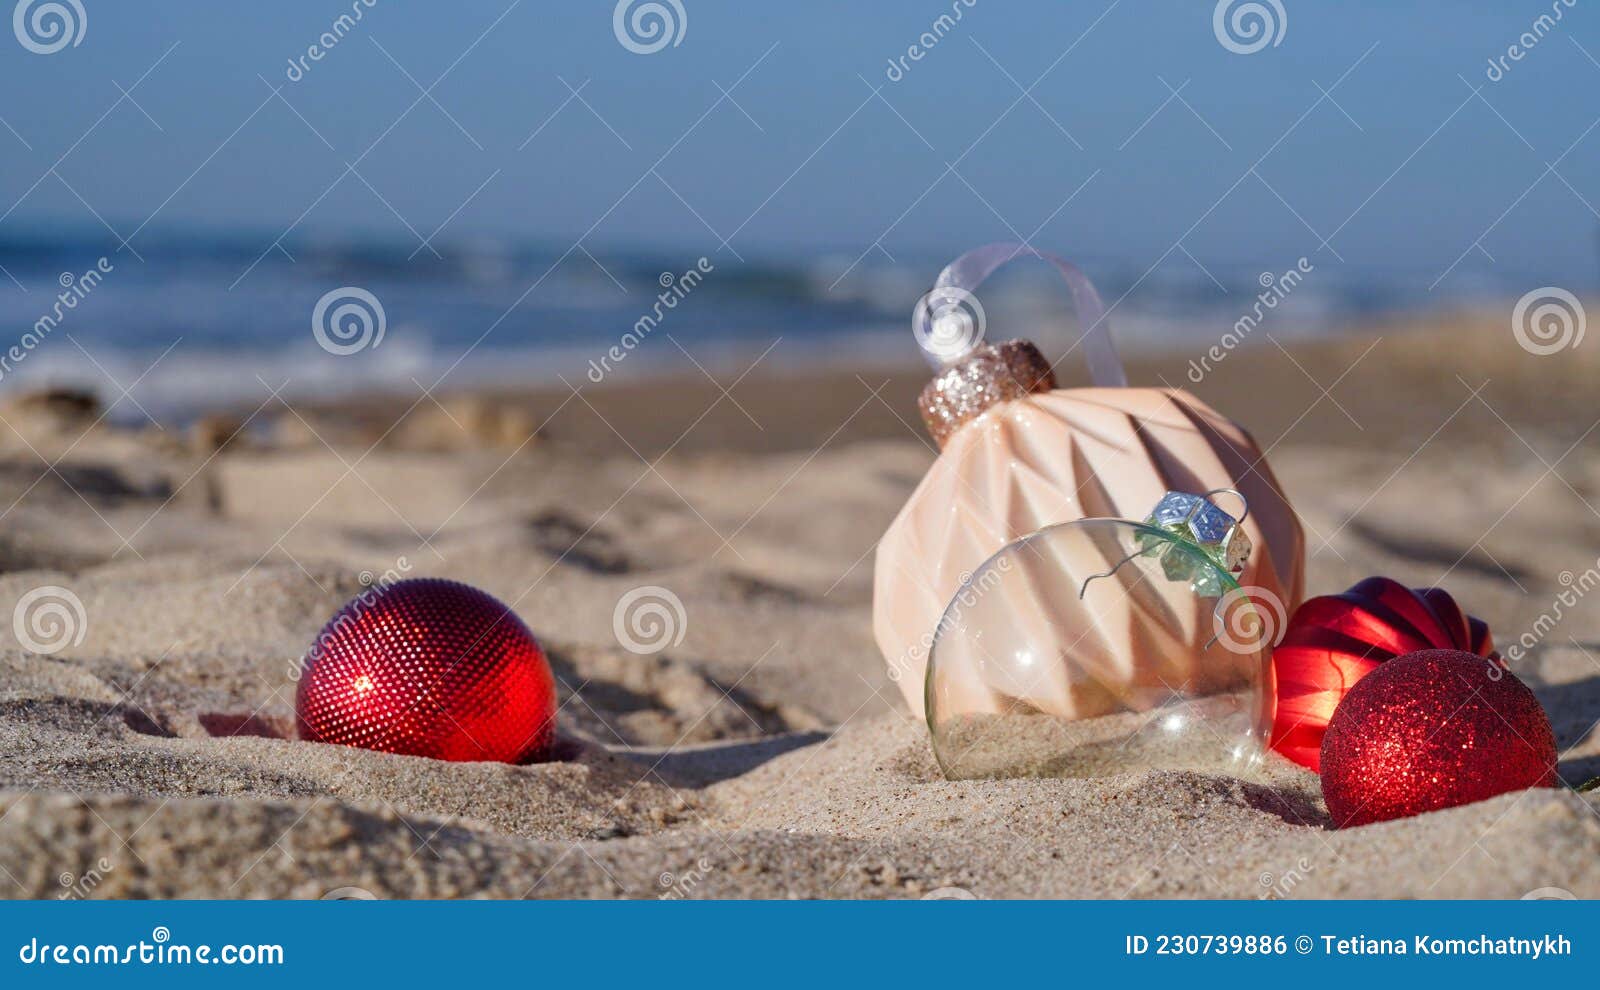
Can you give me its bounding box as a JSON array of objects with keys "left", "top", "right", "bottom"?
[{"left": 294, "top": 577, "right": 555, "bottom": 763}]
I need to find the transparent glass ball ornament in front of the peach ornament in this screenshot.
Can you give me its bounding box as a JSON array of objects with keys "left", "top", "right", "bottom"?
[{"left": 926, "top": 518, "right": 1283, "bottom": 779}]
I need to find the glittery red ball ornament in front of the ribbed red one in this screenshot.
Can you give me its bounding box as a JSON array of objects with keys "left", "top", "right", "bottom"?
[{"left": 1322, "top": 649, "right": 1557, "bottom": 828}]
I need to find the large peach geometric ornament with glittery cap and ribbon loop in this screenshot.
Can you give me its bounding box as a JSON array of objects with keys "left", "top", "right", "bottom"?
[{"left": 872, "top": 243, "right": 1304, "bottom": 718}]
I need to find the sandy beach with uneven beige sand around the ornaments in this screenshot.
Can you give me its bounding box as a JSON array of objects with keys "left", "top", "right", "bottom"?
[{"left": 0, "top": 312, "right": 1600, "bottom": 899}]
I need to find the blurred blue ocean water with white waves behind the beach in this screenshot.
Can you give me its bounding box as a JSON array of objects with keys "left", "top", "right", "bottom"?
[{"left": 0, "top": 234, "right": 1525, "bottom": 419}]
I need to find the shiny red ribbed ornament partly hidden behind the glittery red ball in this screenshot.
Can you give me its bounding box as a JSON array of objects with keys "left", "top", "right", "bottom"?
[{"left": 1272, "top": 577, "right": 1499, "bottom": 769}]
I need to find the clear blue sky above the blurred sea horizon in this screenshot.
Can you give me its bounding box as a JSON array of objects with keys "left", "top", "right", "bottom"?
[{"left": 0, "top": 0, "right": 1600, "bottom": 291}]
